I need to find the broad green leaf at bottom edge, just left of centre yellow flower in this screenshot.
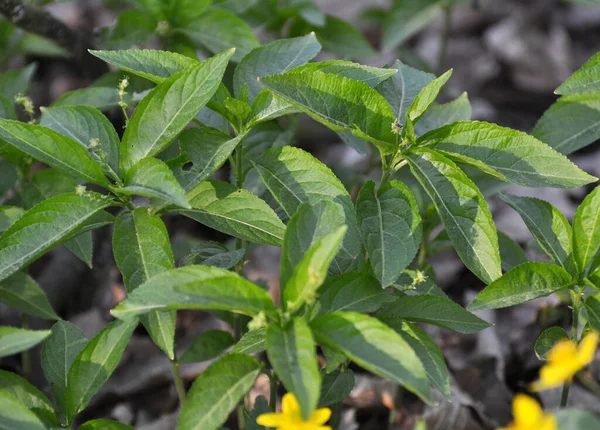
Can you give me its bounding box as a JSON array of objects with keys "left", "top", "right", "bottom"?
[{"left": 177, "top": 354, "right": 260, "bottom": 430}]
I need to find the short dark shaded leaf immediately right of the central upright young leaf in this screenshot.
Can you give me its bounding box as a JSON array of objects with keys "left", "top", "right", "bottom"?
[{"left": 317, "top": 272, "right": 395, "bottom": 315}]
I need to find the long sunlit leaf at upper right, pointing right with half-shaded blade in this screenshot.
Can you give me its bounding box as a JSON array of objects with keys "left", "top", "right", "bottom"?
[{"left": 418, "top": 121, "right": 596, "bottom": 188}]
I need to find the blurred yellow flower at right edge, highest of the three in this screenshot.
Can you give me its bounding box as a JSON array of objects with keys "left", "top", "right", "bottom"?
[{"left": 529, "top": 331, "right": 598, "bottom": 391}]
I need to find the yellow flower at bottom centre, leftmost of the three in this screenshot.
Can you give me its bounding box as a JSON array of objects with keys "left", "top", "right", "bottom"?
[{"left": 256, "top": 393, "right": 331, "bottom": 430}]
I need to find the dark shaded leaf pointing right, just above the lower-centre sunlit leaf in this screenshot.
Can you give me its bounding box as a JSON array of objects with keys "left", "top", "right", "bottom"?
[{"left": 377, "top": 294, "right": 492, "bottom": 333}]
